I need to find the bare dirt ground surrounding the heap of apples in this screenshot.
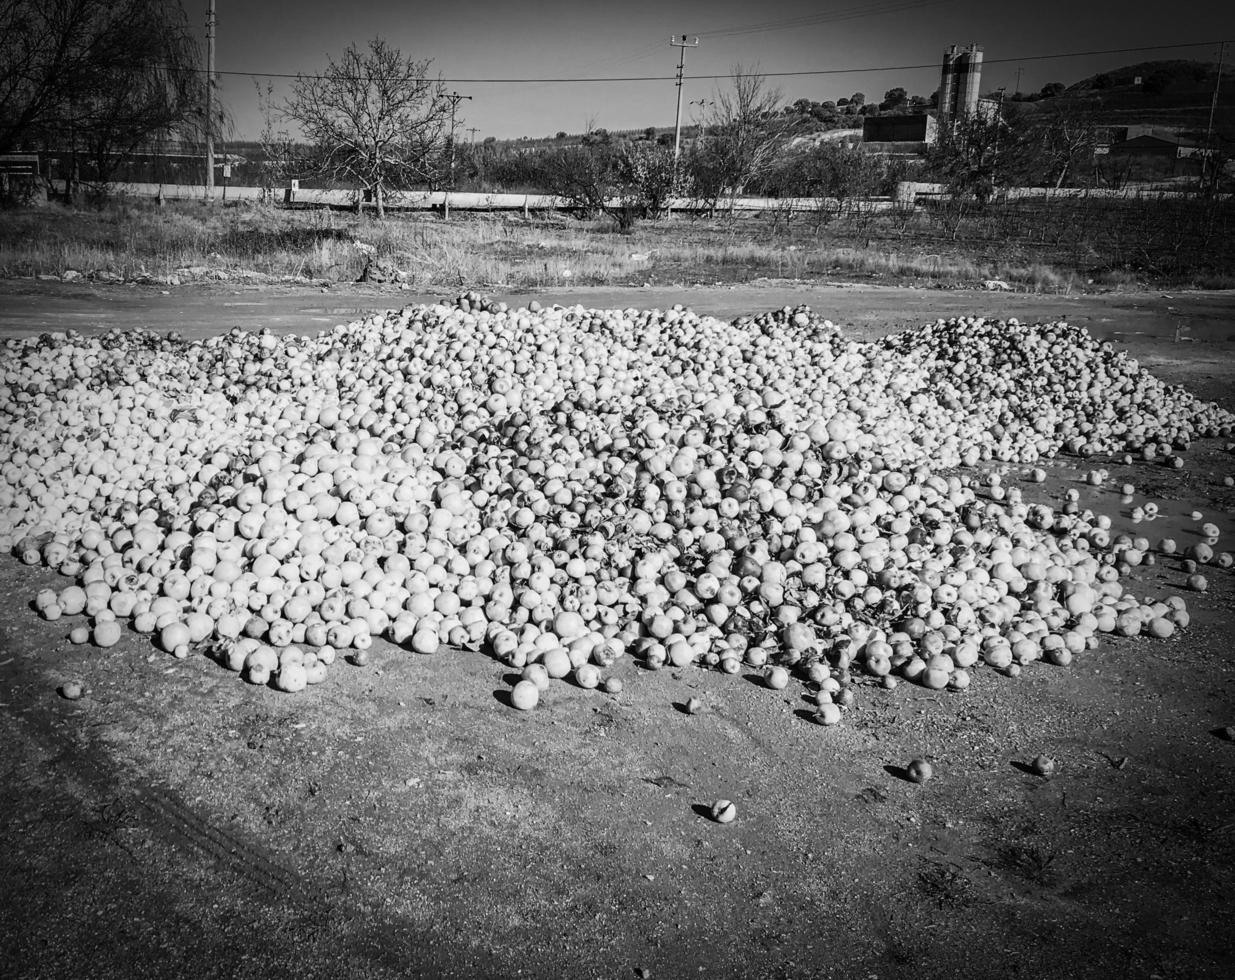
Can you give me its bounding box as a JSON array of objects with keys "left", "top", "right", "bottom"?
[{"left": 0, "top": 278, "right": 1235, "bottom": 980}]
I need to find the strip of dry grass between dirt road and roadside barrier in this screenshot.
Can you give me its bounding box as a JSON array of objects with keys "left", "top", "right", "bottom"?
[{"left": 0, "top": 201, "right": 1230, "bottom": 293}]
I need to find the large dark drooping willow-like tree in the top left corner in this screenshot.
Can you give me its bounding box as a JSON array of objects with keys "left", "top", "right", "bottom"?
[{"left": 0, "top": 0, "right": 207, "bottom": 196}]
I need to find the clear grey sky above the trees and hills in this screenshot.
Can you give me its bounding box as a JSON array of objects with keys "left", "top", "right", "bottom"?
[{"left": 212, "top": 0, "right": 1235, "bottom": 142}]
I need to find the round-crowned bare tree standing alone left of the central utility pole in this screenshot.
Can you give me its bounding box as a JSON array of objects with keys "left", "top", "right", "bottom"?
[{"left": 283, "top": 37, "right": 451, "bottom": 217}]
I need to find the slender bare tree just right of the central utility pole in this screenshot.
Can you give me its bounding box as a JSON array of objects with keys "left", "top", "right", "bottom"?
[{"left": 701, "top": 64, "right": 794, "bottom": 206}]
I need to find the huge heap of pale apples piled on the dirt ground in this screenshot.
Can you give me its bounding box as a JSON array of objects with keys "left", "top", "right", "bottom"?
[{"left": 0, "top": 294, "right": 1235, "bottom": 723}]
